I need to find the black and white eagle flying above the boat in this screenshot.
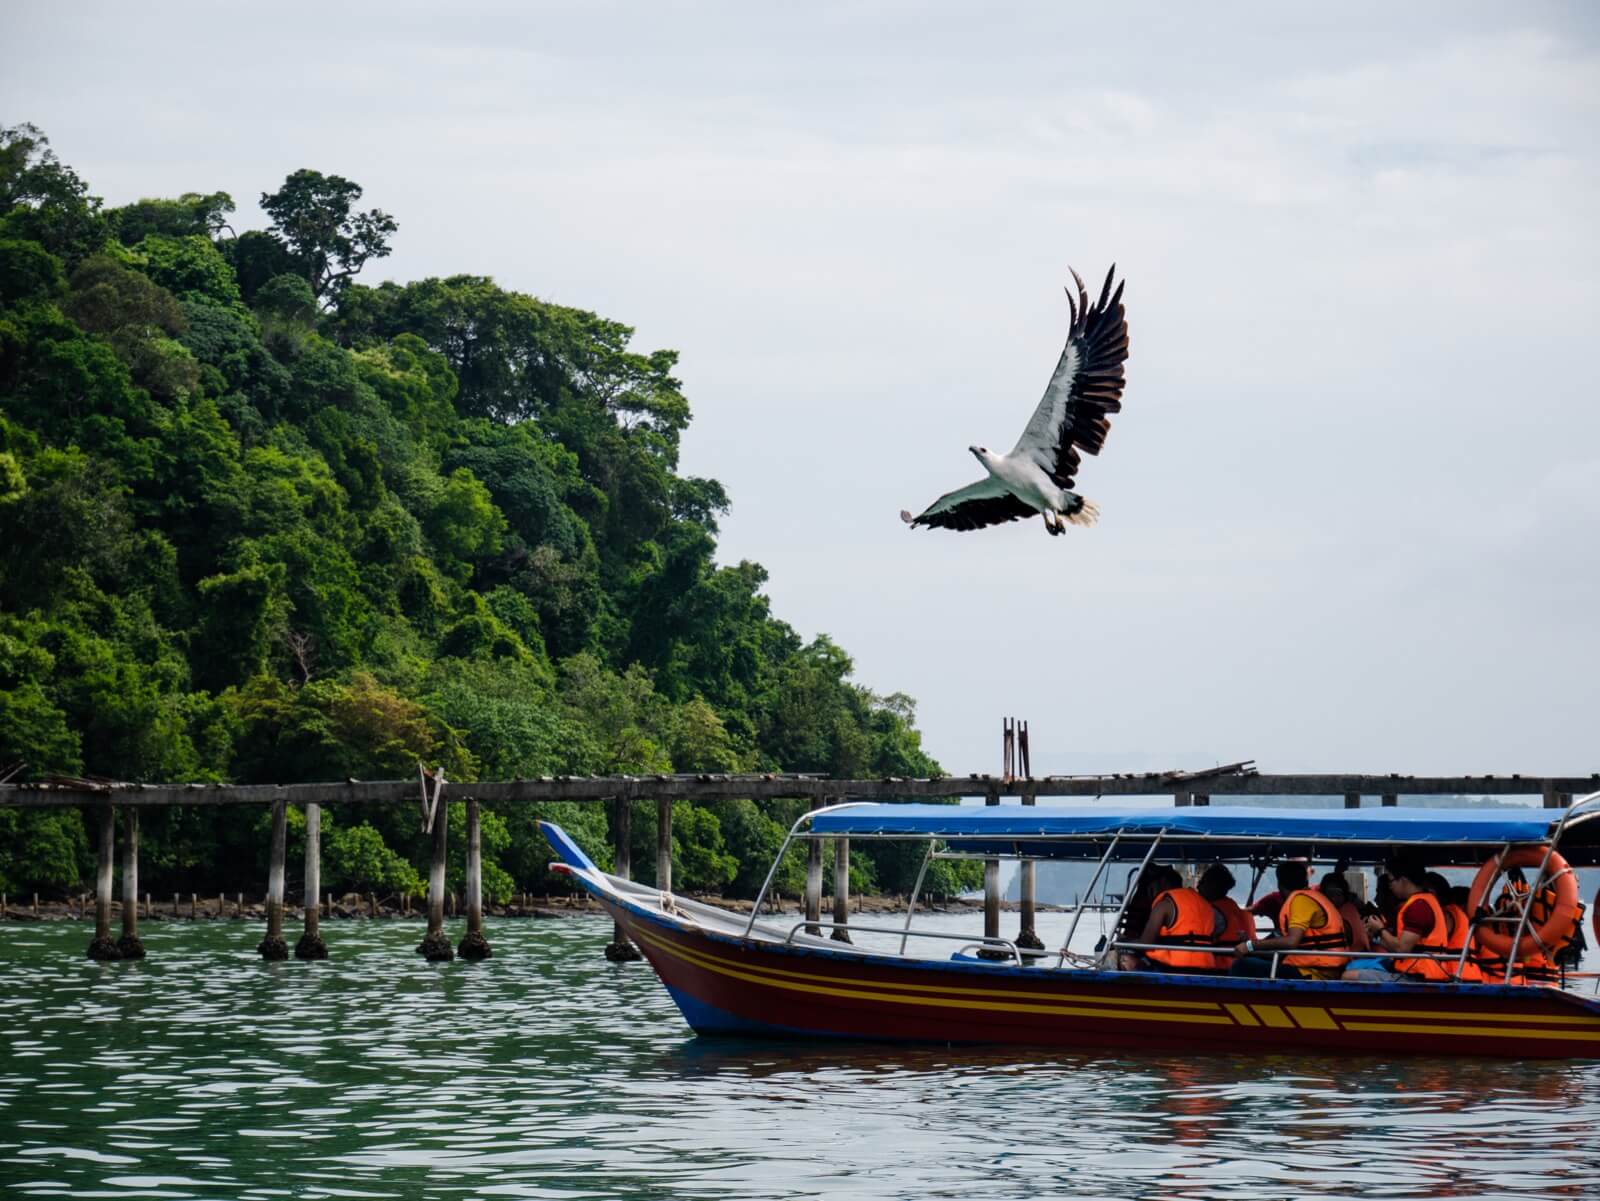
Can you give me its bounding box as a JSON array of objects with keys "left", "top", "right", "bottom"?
[{"left": 901, "top": 264, "right": 1128, "bottom": 534}]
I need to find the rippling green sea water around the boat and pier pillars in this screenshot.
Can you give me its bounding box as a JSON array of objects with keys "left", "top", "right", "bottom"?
[{"left": 0, "top": 920, "right": 1600, "bottom": 1199}]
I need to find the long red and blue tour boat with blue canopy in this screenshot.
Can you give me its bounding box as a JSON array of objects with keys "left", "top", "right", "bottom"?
[{"left": 544, "top": 793, "right": 1600, "bottom": 1059}]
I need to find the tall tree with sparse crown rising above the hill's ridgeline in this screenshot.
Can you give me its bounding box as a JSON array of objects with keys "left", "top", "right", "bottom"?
[{"left": 261, "top": 168, "right": 400, "bottom": 304}]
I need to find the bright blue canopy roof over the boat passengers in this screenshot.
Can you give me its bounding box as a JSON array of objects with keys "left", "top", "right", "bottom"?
[{"left": 810, "top": 804, "right": 1600, "bottom": 865}]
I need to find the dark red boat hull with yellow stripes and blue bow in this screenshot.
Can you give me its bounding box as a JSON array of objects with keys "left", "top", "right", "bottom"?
[{"left": 600, "top": 894, "right": 1600, "bottom": 1059}]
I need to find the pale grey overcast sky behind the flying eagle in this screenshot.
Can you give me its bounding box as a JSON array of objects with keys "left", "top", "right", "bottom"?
[{"left": 12, "top": 3, "right": 1600, "bottom": 774}]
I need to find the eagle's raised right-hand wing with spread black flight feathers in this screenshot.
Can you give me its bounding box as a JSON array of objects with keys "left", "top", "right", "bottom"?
[{"left": 1011, "top": 264, "right": 1128, "bottom": 488}]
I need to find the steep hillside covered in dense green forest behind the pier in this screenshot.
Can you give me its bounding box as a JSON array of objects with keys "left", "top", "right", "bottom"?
[{"left": 0, "top": 125, "right": 957, "bottom": 897}]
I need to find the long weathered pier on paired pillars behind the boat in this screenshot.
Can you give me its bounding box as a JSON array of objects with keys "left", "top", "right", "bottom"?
[{"left": 0, "top": 774, "right": 1600, "bottom": 961}]
